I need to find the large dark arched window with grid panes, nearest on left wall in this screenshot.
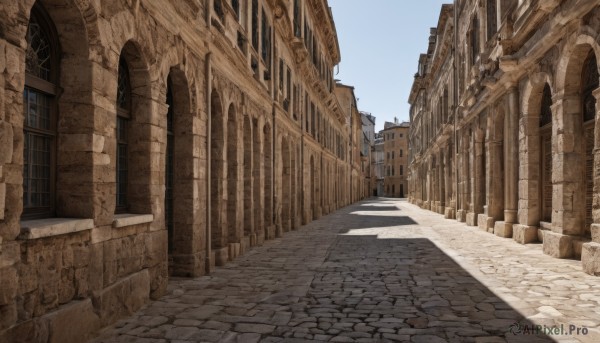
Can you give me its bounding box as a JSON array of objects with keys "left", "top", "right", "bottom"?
[{"left": 23, "top": 4, "right": 60, "bottom": 218}]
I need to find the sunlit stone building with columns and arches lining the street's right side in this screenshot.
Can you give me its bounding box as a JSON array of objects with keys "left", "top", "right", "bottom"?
[{"left": 409, "top": 0, "right": 600, "bottom": 275}]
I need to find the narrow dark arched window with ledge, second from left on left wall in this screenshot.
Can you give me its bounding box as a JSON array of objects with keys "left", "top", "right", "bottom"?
[{"left": 116, "top": 57, "right": 131, "bottom": 213}]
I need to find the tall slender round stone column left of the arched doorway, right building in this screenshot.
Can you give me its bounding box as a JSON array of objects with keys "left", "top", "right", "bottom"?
[{"left": 494, "top": 86, "right": 519, "bottom": 238}]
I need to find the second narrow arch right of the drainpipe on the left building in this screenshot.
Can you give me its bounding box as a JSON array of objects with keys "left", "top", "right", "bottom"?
[{"left": 225, "top": 104, "right": 243, "bottom": 250}]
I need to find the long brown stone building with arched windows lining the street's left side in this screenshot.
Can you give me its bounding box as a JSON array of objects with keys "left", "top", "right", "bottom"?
[{"left": 0, "top": 0, "right": 362, "bottom": 342}]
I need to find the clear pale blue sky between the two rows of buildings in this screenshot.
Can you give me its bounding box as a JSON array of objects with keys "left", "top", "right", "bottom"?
[{"left": 329, "top": 0, "right": 451, "bottom": 131}]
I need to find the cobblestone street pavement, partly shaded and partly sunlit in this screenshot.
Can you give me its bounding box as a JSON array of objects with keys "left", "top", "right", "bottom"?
[{"left": 93, "top": 198, "right": 600, "bottom": 343}]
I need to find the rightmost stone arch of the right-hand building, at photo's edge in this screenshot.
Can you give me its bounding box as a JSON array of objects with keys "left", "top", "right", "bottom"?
[{"left": 552, "top": 39, "right": 599, "bottom": 236}]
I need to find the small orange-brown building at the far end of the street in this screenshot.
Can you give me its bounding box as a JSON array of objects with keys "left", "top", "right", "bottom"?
[{"left": 381, "top": 120, "right": 410, "bottom": 198}]
